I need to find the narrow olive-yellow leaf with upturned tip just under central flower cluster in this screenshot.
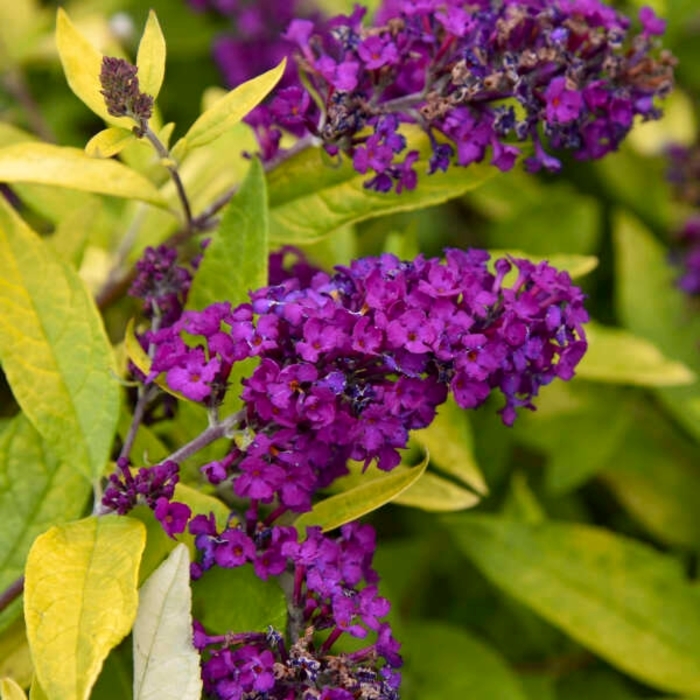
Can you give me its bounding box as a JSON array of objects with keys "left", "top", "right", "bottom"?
[{"left": 294, "top": 454, "right": 429, "bottom": 532}]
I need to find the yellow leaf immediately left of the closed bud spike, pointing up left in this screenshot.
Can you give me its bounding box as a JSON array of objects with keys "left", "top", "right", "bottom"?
[{"left": 56, "top": 7, "right": 134, "bottom": 129}]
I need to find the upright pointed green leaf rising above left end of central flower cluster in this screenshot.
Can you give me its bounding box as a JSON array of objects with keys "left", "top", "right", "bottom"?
[{"left": 187, "top": 158, "right": 269, "bottom": 310}]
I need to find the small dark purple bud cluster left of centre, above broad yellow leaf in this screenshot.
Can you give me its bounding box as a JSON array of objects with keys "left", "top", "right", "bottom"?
[{"left": 102, "top": 459, "right": 192, "bottom": 537}]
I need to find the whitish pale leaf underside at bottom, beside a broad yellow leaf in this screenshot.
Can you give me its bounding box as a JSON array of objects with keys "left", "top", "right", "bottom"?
[{"left": 133, "top": 544, "right": 202, "bottom": 700}]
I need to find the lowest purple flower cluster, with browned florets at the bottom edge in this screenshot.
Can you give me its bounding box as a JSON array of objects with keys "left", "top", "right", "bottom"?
[{"left": 190, "top": 516, "right": 401, "bottom": 700}]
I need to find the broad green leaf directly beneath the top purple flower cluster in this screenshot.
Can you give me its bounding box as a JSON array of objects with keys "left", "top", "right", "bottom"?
[{"left": 268, "top": 130, "right": 497, "bottom": 245}]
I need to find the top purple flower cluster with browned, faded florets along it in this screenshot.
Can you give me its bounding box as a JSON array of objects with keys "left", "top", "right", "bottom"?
[{"left": 250, "top": 0, "right": 674, "bottom": 191}]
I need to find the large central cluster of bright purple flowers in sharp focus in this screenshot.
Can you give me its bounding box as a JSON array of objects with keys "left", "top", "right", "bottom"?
[{"left": 147, "top": 249, "right": 588, "bottom": 512}]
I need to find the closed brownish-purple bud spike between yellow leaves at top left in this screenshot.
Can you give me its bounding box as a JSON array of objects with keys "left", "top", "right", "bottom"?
[{"left": 100, "top": 56, "right": 153, "bottom": 135}]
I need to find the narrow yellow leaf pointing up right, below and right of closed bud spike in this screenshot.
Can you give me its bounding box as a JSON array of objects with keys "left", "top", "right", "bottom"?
[{"left": 173, "top": 59, "right": 287, "bottom": 160}]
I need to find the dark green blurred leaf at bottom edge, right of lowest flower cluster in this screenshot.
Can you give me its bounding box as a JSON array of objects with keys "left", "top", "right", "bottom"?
[{"left": 401, "top": 622, "right": 526, "bottom": 700}]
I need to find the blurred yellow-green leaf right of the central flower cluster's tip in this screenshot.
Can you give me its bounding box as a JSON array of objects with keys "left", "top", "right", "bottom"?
[{"left": 576, "top": 323, "right": 696, "bottom": 387}]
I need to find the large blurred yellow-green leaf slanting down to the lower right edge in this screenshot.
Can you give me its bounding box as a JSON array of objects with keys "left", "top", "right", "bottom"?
[{"left": 443, "top": 514, "right": 700, "bottom": 693}]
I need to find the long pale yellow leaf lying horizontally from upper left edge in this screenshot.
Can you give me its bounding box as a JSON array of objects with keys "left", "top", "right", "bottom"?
[{"left": 0, "top": 143, "right": 168, "bottom": 208}]
